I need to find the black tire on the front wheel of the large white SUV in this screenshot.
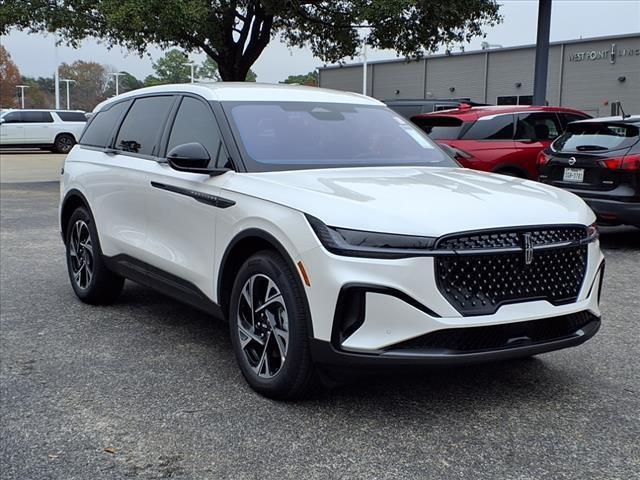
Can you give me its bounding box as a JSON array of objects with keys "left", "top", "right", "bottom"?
[{"left": 228, "top": 250, "right": 316, "bottom": 400}]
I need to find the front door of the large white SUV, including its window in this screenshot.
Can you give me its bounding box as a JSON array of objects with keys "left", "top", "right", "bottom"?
[{"left": 144, "top": 96, "right": 229, "bottom": 299}]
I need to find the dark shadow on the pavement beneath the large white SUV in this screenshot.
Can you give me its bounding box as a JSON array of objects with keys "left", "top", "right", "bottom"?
[{"left": 111, "top": 282, "right": 572, "bottom": 413}]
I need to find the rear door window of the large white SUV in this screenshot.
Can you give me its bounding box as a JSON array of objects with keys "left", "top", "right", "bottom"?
[{"left": 115, "top": 96, "right": 174, "bottom": 155}]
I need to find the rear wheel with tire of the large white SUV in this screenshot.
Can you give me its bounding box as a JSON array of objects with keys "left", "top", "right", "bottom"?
[{"left": 65, "top": 207, "right": 124, "bottom": 305}]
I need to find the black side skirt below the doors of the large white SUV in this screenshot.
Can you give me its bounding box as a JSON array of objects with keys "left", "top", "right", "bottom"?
[{"left": 103, "top": 254, "right": 225, "bottom": 319}]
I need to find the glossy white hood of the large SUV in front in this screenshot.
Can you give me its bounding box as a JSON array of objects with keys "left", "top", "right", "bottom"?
[{"left": 223, "top": 167, "right": 595, "bottom": 237}]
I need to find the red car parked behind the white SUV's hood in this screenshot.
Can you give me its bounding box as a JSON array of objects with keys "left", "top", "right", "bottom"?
[{"left": 411, "top": 105, "right": 590, "bottom": 180}]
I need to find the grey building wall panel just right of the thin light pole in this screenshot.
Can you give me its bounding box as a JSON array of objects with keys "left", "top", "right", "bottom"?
[{"left": 373, "top": 60, "right": 424, "bottom": 100}]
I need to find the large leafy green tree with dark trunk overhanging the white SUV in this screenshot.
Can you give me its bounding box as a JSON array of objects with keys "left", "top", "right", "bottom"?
[{"left": 0, "top": 0, "right": 501, "bottom": 80}]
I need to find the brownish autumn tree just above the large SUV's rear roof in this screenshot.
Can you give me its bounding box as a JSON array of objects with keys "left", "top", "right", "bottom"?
[{"left": 59, "top": 60, "right": 111, "bottom": 111}]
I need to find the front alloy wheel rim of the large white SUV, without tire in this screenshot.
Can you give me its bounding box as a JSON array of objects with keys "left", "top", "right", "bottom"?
[{"left": 236, "top": 274, "right": 289, "bottom": 378}]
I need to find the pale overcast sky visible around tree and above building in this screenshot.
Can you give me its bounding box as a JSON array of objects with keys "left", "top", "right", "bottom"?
[{"left": 0, "top": 0, "right": 640, "bottom": 83}]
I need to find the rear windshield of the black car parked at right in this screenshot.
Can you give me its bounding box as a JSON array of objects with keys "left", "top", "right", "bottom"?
[{"left": 553, "top": 122, "right": 639, "bottom": 152}]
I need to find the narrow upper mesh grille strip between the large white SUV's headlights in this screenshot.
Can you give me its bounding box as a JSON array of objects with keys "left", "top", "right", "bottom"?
[{"left": 436, "top": 227, "right": 586, "bottom": 250}]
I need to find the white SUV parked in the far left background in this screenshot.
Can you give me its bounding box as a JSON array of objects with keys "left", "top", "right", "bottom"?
[{"left": 0, "top": 109, "right": 87, "bottom": 153}]
